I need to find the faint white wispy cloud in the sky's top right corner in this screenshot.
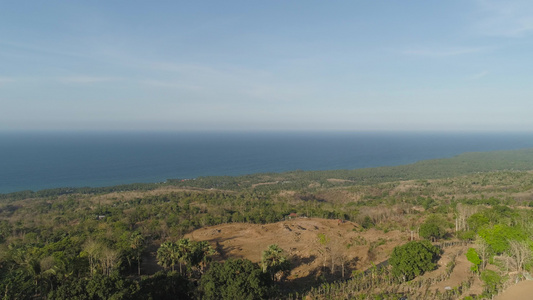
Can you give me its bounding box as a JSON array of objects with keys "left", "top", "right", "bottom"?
[{"left": 475, "top": 0, "right": 533, "bottom": 38}]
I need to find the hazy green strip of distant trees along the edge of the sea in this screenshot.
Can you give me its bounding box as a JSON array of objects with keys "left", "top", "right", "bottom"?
[{"left": 4, "top": 149, "right": 533, "bottom": 200}]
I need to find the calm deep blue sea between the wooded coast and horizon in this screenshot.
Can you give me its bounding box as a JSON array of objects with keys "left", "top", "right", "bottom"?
[{"left": 0, "top": 132, "right": 533, "bottom": 193}]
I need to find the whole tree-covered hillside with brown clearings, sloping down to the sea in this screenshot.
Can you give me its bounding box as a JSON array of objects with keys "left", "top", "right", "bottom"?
[{"left": 0, "top": 150, "right": 533, "bottom": 299}]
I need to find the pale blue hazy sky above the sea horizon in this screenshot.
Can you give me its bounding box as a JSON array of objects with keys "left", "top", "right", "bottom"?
[{"left": 0, "top": 0, "right": 533, "bottom": 131}]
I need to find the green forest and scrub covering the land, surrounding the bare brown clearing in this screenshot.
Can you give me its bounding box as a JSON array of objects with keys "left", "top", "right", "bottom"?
[{"left": 0, "top": 149, "right": 533, "bottom": 299}]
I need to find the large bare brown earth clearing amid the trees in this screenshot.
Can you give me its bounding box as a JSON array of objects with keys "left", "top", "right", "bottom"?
[{"left": 186, "top": 218, "right": 409, "bottom": 279}]
